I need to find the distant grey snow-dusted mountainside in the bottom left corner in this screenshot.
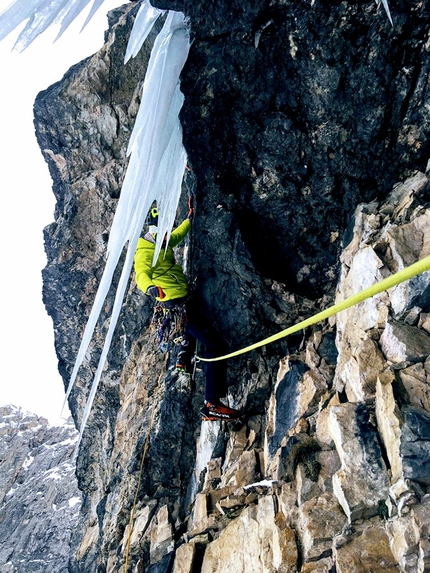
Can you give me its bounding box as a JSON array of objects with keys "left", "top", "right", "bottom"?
[{"left": 0, "top": 406, "right": 81, "bottom": 573}]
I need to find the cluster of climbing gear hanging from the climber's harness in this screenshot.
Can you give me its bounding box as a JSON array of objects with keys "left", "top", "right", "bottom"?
[{"left": 151, "top": 304, "right": 187, "bottom": 352}]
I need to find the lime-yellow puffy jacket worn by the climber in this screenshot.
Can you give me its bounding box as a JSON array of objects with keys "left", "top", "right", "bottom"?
[{"left": 134, "top": 219, "right": 191, "bottom": 302}]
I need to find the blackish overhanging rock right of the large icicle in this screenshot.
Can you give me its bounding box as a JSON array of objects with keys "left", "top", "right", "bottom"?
[{"left": 161, "top": 2, "right": 429, "bottom": 300}]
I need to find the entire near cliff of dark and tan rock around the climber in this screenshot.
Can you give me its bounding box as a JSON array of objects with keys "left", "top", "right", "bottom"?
[{"left": 35, "top": 0, "right": 430, "bottom": 573}]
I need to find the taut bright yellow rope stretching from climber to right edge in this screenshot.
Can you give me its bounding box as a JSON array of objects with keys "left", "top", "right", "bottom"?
[{"left": 197, "top": 256, "right": 430, "bottom": 362}]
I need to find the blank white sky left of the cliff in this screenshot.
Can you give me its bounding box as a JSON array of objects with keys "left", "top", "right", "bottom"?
[{"left": 0, "top": 0, "right": 124, "bottom": 424}]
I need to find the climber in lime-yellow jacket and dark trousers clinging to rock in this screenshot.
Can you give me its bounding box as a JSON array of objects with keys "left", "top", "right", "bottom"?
[{"left": 134, "top": 202, "right": 240, "bottom": 421}]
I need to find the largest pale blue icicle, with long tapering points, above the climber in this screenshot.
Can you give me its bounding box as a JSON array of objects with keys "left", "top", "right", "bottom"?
[{"left": 66, "top": 3, "right": 190, "bottom": 450}]
